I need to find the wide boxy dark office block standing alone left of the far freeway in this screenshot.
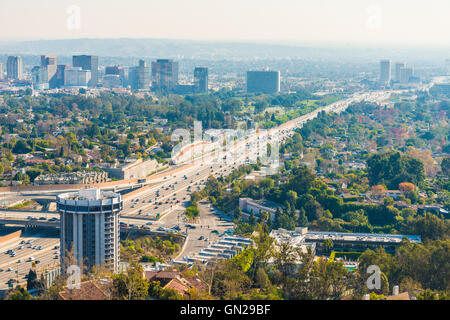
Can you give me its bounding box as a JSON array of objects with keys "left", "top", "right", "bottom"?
[{"left": 247, "top": 70, "right": 280, "bottom": 94}]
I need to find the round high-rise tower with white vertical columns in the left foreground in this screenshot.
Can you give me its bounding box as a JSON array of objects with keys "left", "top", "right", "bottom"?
[{"left": 56, "top": 189, "right": 123, "bottom": 272}]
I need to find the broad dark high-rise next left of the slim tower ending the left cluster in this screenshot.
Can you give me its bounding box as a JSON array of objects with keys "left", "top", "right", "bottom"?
[{"left": 152, "top": 59, "right": 178, "bottom": 92}]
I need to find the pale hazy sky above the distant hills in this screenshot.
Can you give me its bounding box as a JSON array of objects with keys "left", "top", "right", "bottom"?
[{"left": 0, "top": 0, "right": 450, "bottom": 46}]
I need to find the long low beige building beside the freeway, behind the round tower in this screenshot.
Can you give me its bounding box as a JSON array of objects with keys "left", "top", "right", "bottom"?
[{"left": 102, "top": 159, "right": 161, "bottom": 180}]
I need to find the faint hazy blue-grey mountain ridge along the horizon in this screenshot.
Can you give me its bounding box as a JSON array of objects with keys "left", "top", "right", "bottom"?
[{"left": 0, "top": 38, "right": 444, "bottom": 61}]
